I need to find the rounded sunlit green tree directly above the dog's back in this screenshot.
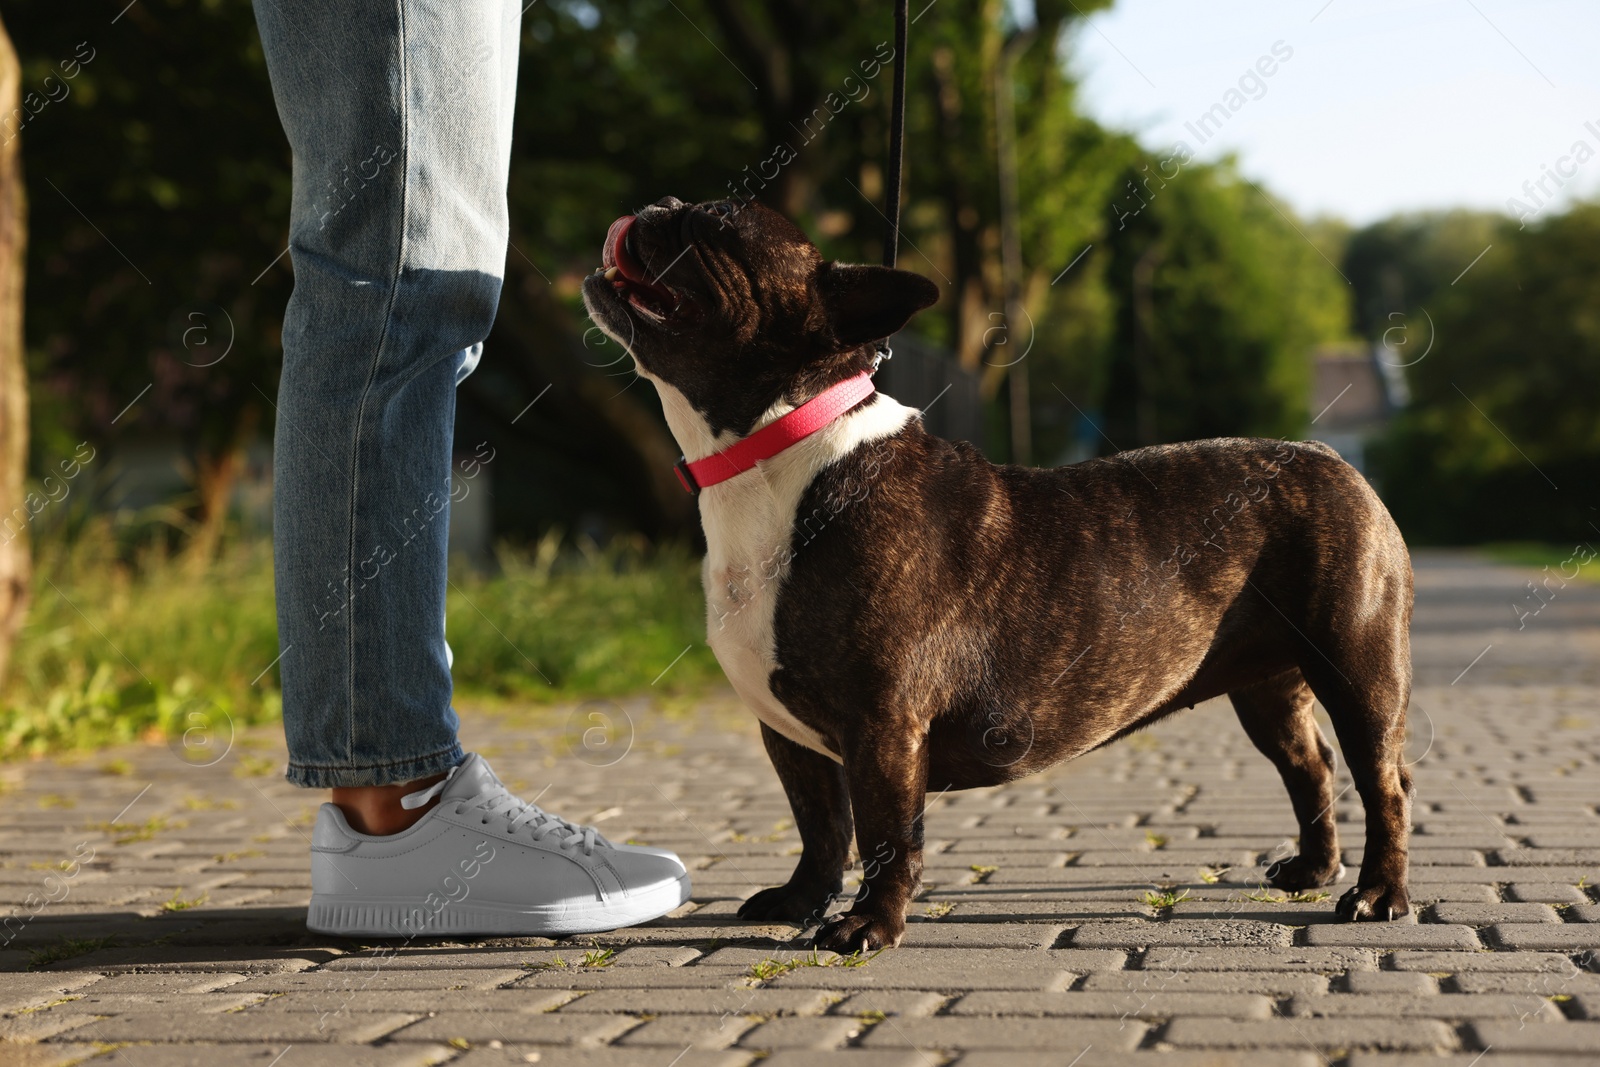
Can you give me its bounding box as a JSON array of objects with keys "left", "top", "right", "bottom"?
[{"left": 1104, "top": 152, "right": 1349, "bottom": 446}]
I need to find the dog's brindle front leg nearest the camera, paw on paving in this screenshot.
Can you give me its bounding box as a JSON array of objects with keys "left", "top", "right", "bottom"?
[{"left": 816, "top": 723, "right": 928, "bottom": 952}]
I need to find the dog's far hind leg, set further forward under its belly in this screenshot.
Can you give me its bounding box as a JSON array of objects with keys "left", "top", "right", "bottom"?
[{"left": 1227, "top": 669, "right": 1344, "bottom": 891}]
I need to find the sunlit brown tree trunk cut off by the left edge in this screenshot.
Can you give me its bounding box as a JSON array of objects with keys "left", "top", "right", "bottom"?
[{"left": 0, "top": 8, "right": 32, "bottom": 680}]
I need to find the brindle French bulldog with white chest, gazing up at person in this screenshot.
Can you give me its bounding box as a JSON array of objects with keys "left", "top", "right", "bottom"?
[{"left": 584, "top": 197, "right": 1411, "bottom": 952}]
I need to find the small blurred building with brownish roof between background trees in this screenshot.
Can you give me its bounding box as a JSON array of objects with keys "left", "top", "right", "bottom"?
[{"left": 1306, "top": 344, "right": 1410, "bottom": 474}]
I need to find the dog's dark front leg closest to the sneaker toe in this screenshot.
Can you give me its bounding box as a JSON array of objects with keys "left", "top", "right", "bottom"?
[{"left": 739, "top": 723, "right": 850, "bottom": 926}]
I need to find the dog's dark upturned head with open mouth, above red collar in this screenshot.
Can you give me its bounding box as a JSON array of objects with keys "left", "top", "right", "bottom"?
[{"left": 584, "top": 197, "right": 939, "bottom": 434}]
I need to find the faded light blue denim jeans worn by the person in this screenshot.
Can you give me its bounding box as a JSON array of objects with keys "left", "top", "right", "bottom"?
[{"left": 256, "top": 0, "right": 520, "bottom": 787}]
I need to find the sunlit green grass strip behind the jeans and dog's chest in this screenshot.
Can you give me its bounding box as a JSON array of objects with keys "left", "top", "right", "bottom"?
[{"left": 0, "top": 520, "right": 722, "bottom": 758}]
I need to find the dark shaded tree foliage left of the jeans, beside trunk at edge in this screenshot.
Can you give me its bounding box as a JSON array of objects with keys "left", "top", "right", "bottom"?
[{"left": 10, "top": 0, "right": 290, "bottom": 555}]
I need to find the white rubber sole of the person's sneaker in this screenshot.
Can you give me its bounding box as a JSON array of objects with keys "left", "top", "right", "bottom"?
[{"left": 306, "top": 873, "right": 690, "bottom": 937}]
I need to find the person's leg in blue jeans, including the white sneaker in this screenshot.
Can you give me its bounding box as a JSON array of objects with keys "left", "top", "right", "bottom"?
[{"left": 256, "top": 0, "right": 690, "bottom": 936}]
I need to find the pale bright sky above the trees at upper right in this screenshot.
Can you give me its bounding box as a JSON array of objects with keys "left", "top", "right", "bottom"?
[{"left": 1069, "top": 0, "right": 1600, "bottom": 224}]
